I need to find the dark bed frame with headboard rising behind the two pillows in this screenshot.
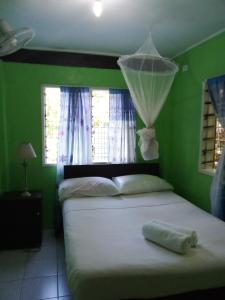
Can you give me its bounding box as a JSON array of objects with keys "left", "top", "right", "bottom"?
[{"left": 55, "top": 163, "right": 225, "bottom": 300}]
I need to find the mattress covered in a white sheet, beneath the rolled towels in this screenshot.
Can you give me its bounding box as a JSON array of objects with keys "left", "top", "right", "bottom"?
[{"left": 63, "top": 192, "right": 225, "bottom": 300}]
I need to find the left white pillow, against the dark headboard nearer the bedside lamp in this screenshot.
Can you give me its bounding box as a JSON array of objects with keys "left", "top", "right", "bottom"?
[{"left": 58, "top": 177, "right": 119, "bottom": 200}]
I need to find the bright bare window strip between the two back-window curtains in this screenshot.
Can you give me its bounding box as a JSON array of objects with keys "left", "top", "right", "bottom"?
[{"left": 92, "top": 90, "right": 109, "bottom": 163}]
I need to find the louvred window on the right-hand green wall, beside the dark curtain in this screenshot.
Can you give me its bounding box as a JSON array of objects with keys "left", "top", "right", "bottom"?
[{"left": 200, "top": 82, "right": 225, "bottom": 172}]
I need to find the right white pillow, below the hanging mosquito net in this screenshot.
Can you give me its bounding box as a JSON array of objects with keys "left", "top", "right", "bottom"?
[{"left": 113, "top": 174, "right": 173, "bottom": 194}]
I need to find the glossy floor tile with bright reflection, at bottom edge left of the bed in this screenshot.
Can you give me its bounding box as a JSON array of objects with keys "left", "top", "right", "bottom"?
[{"left": 20, "top": 276, "right": 57, "bottom": 300}]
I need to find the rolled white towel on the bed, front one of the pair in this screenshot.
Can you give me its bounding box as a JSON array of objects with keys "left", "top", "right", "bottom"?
[{"left": 142, "top": 221, "right": 191, "bottom": 254}]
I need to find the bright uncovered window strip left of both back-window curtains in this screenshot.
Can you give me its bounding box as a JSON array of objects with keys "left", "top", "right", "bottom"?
[{"left": 44, "top": 87, "right": 60, "bottom": 164}]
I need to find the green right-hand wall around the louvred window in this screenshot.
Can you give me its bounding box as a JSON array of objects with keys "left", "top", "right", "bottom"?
[{"left": 163, "top": 33, "right": 225, "bottom": 210}]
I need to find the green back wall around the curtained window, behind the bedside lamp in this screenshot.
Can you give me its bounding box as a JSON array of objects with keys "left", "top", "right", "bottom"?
[{"left": 0, "top": 62, "right": 146, "bottom": 227}]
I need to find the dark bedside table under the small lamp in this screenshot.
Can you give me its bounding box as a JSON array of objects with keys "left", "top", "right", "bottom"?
[{"left": 0, "top": 191, "right": 42, "bottom": 249}]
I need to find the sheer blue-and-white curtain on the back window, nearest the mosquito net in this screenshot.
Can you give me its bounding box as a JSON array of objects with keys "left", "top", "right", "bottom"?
[{"left": 108, "top": 89, "right": 136, "bottom": 163}]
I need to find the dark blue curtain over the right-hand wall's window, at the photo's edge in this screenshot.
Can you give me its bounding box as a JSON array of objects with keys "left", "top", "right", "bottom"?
[{"left": 207, "top": 76, "right": 225, "bottom": 221}]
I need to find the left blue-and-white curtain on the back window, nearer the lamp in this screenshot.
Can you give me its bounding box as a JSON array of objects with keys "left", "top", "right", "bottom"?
[{"left": 57, "top": 87, "right": 91, "bottom": 181}]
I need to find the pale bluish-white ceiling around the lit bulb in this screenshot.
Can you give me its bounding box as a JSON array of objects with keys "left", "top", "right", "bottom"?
[{"left": 0, "top": 0, "right": 225, "bottom": 57}]
